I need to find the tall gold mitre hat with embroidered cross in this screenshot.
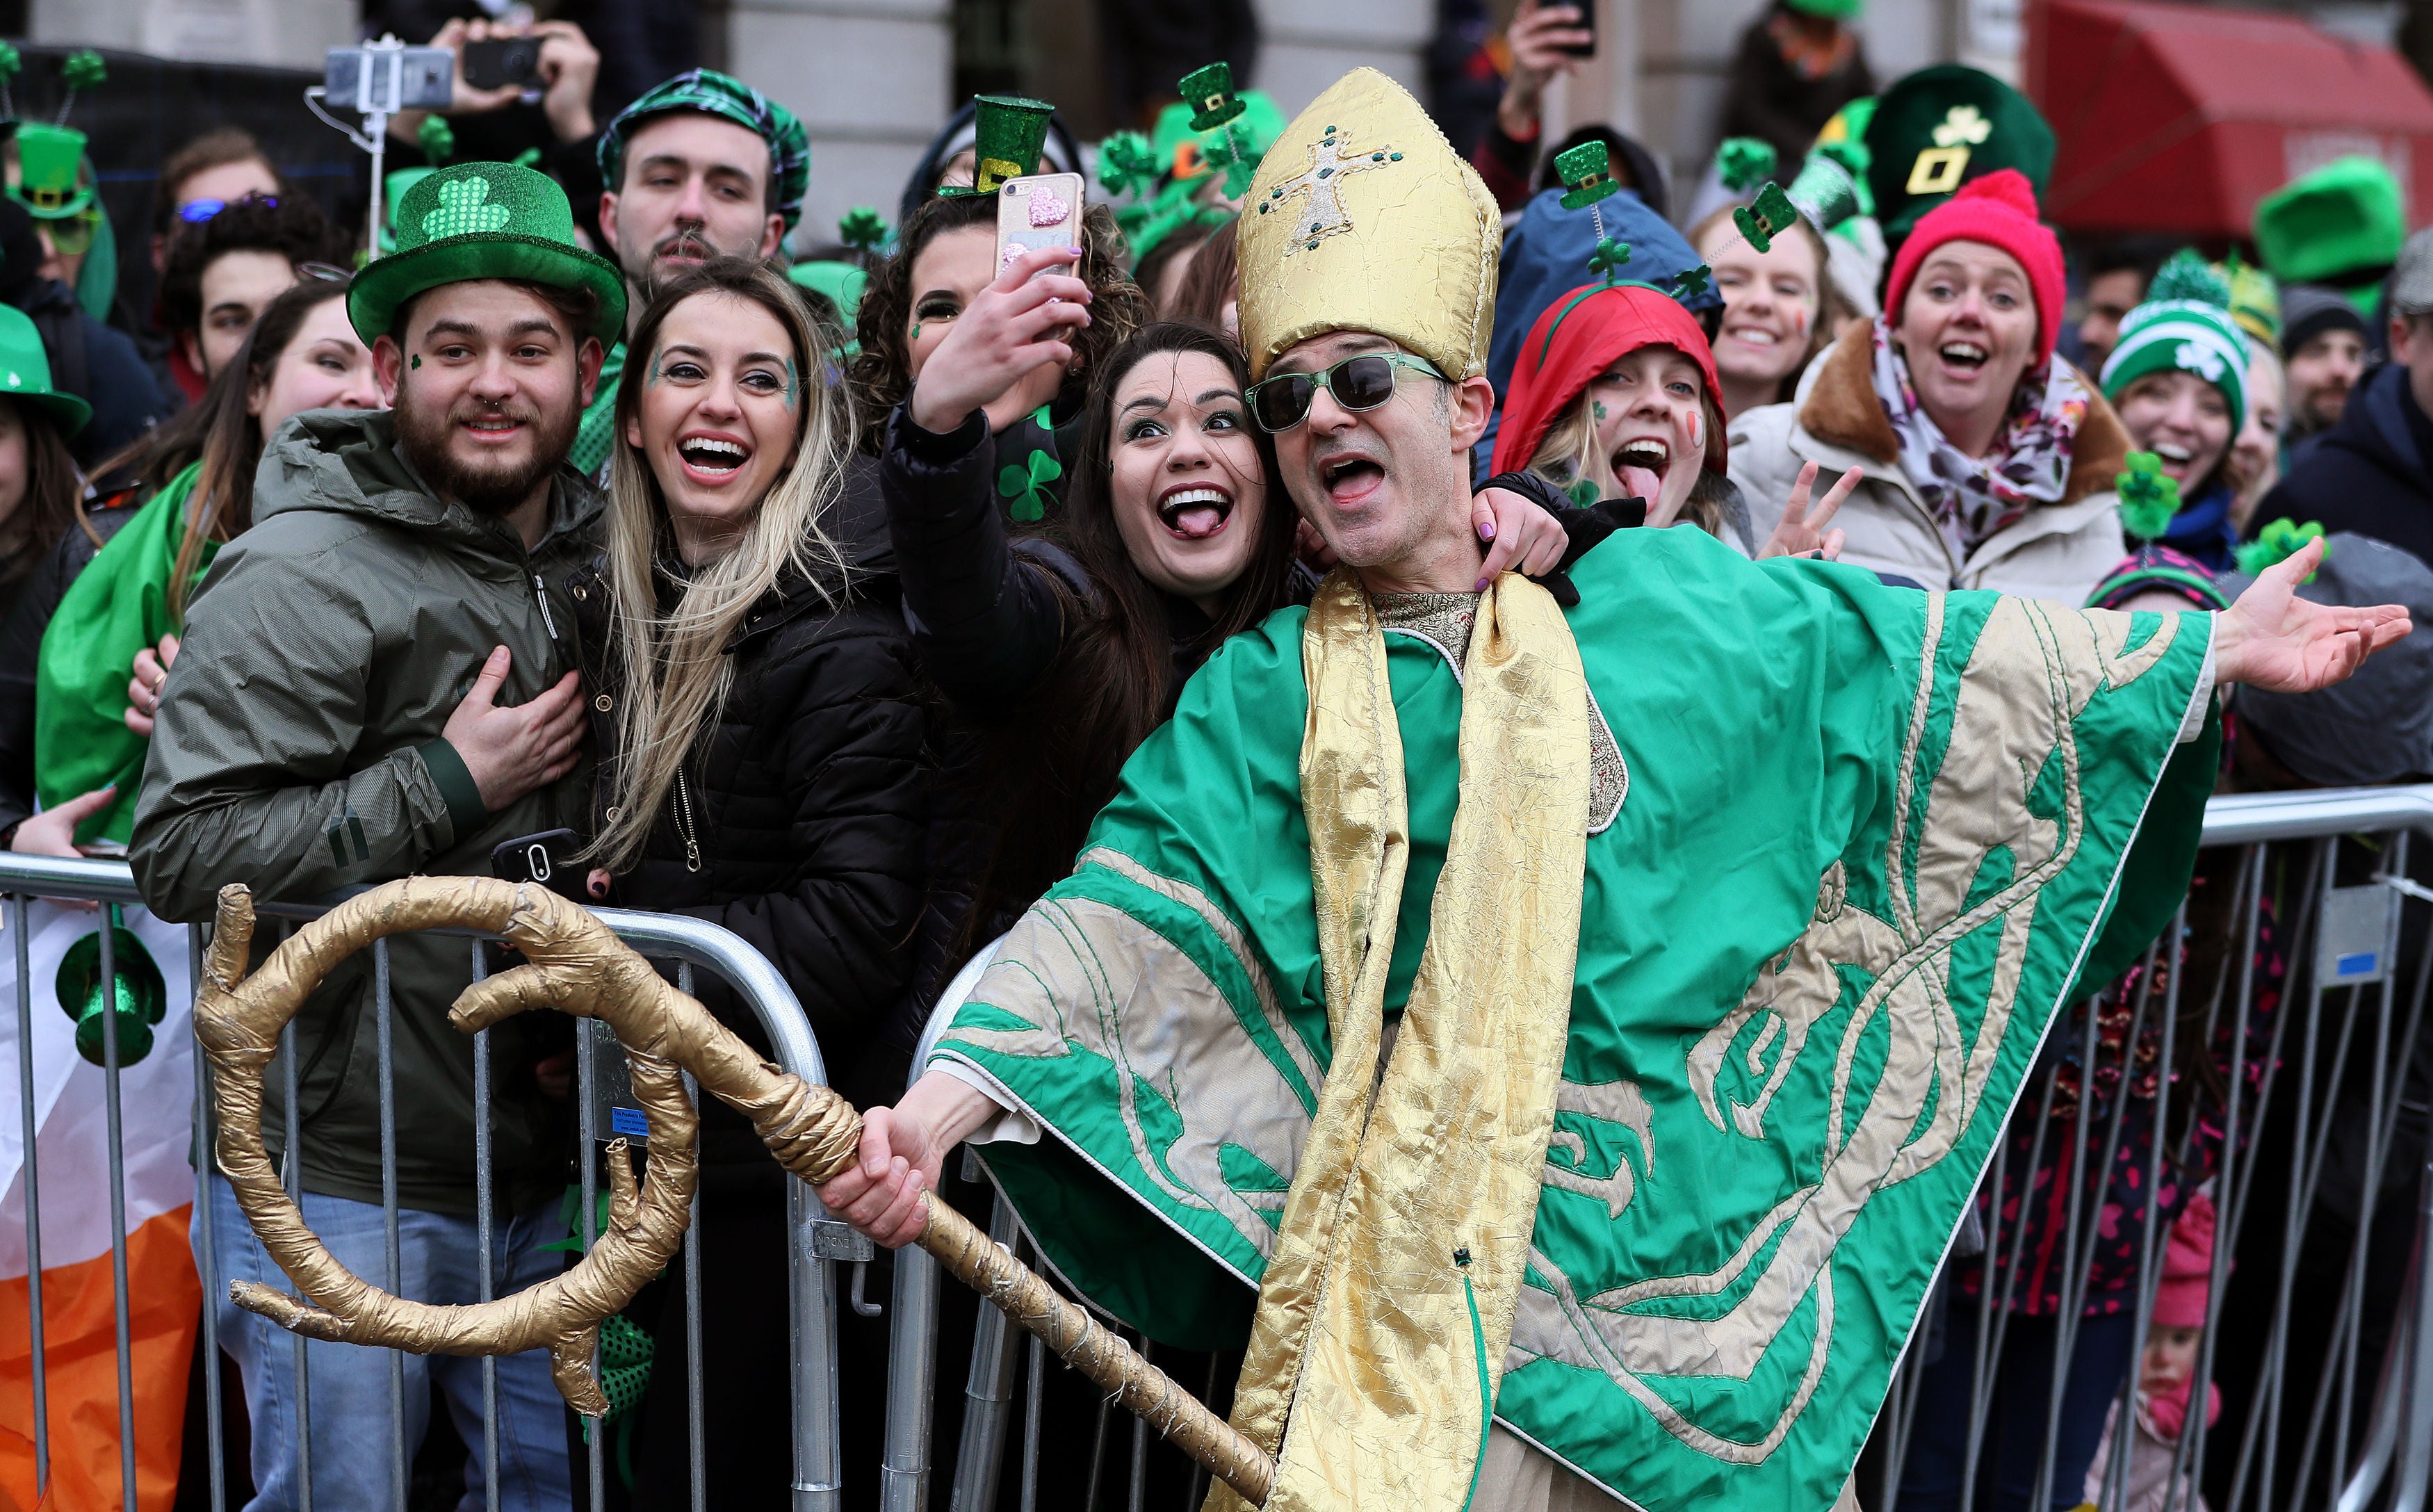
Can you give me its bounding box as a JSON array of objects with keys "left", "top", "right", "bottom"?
[{"left": 1239, "top": 68, "right": 1504, "bottom": 380}]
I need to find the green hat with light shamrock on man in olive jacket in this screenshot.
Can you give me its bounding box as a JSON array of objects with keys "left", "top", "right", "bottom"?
[{"left": 345, "top": 163, "right": 626, "bottom": 346}]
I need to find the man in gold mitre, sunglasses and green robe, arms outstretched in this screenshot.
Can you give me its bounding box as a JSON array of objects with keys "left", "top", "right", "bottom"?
[{"left": 822, "top": 71, "right": 2409, "bottom": 1512}]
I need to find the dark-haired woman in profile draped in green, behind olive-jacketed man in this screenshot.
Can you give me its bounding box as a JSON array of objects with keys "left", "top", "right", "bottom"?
[{"left": 0, "top": 280, "right": 382, "bottom": 854}]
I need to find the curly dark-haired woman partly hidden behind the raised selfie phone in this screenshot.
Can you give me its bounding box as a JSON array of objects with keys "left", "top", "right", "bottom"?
[{"left": 852, "top": 195, "right": 1148, "bottom": 523}]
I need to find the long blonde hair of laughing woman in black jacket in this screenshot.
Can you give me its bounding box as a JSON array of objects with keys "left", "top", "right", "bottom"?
[{"left": 587, "top": 258, "right": 854, "bottom": 872}]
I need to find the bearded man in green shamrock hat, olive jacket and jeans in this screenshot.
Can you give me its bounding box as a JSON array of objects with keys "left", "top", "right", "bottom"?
[{"left": 131, "top": 163, "right": 626, "bottom": 1512}]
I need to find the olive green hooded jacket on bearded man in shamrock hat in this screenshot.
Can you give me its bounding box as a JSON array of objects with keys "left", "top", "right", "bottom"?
[{"left": 129, "top": 409, "right": 601, "bottom": 1212}]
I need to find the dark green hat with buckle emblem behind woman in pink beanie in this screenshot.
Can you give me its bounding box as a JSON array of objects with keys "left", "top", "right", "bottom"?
[{"left": 1866, "top": 63, "right": 2053, "bottom": 241}]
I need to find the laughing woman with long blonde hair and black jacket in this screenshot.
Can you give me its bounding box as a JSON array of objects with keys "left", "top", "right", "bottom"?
[{"left": 567, "top": 258, "right": 927, "bottom": 1507}]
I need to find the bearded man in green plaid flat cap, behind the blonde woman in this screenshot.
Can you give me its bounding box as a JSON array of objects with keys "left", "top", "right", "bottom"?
[{"left": 569, "top": 68, "right": 811, "bottom": 485}]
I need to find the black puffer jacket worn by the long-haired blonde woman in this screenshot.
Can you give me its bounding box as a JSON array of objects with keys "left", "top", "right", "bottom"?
[{"left": 567, "top": 498, "right": 927, "bottom": 1130}]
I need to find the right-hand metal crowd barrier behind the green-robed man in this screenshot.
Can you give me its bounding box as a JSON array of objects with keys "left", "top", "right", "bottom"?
[{"left": 881, "top": 784, "right": 2433, "bottom": 1512}]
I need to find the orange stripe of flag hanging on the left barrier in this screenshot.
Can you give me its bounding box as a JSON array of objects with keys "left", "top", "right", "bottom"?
[{"left": 0, "top": 1205, "right": 202, "bottom": 1512}]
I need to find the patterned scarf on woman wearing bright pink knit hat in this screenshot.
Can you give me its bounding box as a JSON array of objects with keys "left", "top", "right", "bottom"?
[{"left": 1876, "top": 316, "right": 2088, "bottom": 562}]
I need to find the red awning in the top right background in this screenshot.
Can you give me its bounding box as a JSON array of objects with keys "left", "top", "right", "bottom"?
[{"left": 2027, "top": 0, "right": 2433, "bottom": 241}]
